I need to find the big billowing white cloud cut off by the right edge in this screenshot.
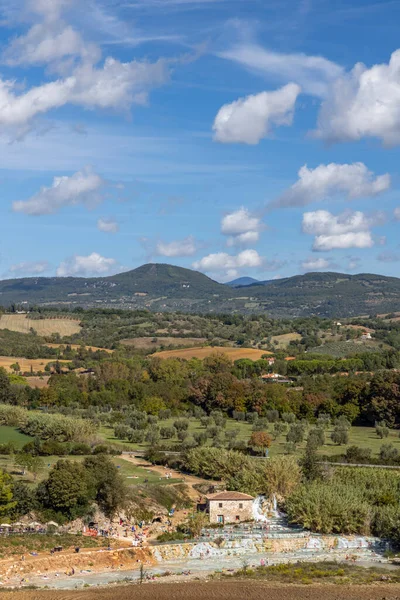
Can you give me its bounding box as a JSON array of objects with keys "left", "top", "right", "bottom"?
[{"left": 315, "top": 50, "right": 400, "bottom": 146}]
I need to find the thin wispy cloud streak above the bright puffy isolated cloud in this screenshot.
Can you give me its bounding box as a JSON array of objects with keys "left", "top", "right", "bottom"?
[{"left": 219, "top": 42, "right": 343, "bottom": 97}]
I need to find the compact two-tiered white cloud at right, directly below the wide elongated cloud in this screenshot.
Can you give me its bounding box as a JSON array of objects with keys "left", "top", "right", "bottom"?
[{"left": 303, "top": 210, "right": 374, "bottom": 251}]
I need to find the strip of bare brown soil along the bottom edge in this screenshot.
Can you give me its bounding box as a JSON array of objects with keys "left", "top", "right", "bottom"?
[{"left": 0, "top": 581, "right": 400, "bottom": 600}]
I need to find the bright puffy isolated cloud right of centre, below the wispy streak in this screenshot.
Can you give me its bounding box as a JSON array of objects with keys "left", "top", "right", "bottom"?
[{"left": 213, "top": 83, "right": 301, "bottom": 144}]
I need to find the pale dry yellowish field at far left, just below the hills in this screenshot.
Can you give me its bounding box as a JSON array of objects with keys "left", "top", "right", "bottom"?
[{"left": 0, "top": 315, "right": 81, "bottom": 336}]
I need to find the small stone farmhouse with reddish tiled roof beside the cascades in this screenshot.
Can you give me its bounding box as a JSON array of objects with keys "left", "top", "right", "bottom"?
[{"left": 207, "top": 492, "right": 254, "bottom": 525}]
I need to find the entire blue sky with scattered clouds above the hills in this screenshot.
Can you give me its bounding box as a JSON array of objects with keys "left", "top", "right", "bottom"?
[{"left": 0, "top": 0, "right": 400, "bottom": 281}]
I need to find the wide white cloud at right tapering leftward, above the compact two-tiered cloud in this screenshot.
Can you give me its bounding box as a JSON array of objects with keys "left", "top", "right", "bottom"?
[{"left": 270, "top": 162, "right": 391, "bottom": 208}]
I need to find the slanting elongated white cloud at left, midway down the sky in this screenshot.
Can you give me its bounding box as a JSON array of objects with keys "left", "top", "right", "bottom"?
[{"left": 12, "top": 167, "right": 105, "bottom": 216}]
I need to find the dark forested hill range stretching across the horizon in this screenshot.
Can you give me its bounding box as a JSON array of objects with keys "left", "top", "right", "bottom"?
[{"left": 0, "top": 264, "right": 400, "bottom": 318}]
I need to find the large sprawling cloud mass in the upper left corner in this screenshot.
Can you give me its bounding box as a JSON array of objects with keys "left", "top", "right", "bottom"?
[{"left": 0, "top": 0, "right": 169, "bottom": 135}]
